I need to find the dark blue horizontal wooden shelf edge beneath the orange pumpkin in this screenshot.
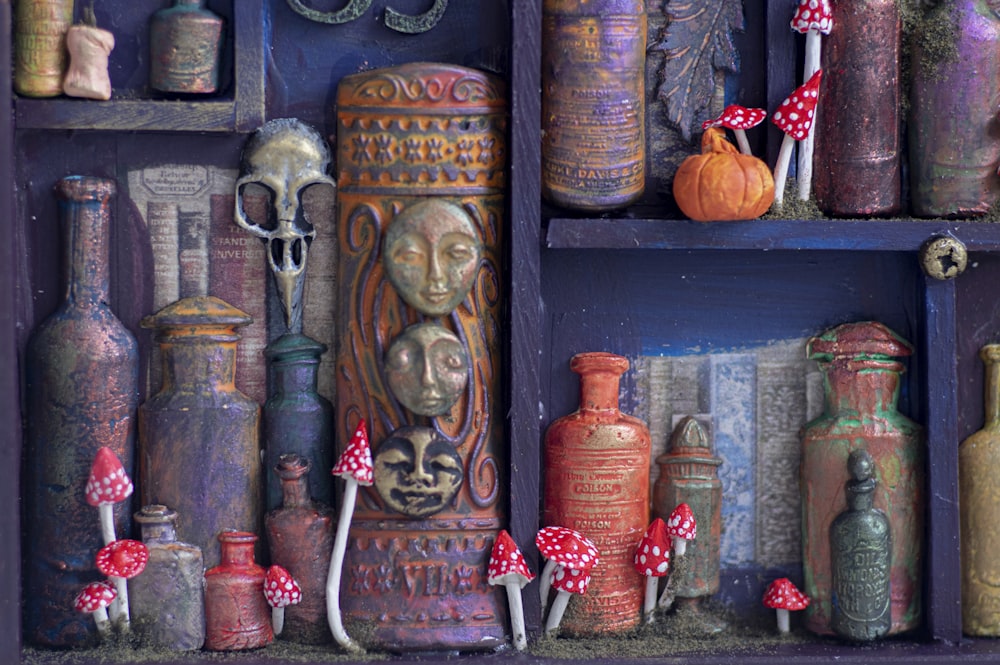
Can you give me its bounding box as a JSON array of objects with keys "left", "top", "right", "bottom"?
[{"left": 545, "top": 218, "right": 1000, "bottom": 252}]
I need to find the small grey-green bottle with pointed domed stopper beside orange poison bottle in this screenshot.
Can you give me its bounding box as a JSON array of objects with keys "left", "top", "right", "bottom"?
[{"left": 653, "top": 416, "right": 722, "bottom": 598}]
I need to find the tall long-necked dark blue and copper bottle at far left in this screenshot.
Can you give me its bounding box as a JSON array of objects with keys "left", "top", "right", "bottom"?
[{"left": 21, "top": 176, "right": 139, "bottom": 646}]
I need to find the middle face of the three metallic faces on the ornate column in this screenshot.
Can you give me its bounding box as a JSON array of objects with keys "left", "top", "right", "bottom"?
[{"left": 385, "top": 323, "right": 469, "bottom": 416}]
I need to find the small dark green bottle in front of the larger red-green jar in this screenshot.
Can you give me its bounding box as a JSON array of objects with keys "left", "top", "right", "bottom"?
[{"left": 830, "top": 449, "right": 892, "bottom": 642}]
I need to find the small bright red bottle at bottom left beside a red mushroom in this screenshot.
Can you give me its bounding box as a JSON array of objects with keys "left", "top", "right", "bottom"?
[{"left": 205, "top": 531, "right": 274, "bottom": 651}]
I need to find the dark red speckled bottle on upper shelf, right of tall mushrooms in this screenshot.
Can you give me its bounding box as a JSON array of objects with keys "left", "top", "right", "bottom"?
[{"left": 813, "top": 0, "right": 902, "bottom": 217}]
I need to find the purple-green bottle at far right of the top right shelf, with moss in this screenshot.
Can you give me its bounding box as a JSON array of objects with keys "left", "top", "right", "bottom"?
[{"left": 909, "top": 0, "right": 1000, "bottom": 217}]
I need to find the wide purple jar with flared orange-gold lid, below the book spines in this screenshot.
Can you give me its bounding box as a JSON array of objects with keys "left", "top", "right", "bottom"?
[{"left": 139, "top": 296, "right": 264, "bottom": 567}]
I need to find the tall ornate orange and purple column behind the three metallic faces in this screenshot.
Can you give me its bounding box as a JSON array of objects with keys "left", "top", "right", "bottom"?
[{"left": 336, "top": 63, "right": 507, "bottom": 652}]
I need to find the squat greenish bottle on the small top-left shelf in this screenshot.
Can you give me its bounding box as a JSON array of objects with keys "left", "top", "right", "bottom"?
[{"left": 149, "top": 0, "right": 224, "bottom": 94}]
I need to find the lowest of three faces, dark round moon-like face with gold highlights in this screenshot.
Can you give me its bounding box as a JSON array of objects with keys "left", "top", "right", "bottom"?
[{"left": 374, "top": 427, "right": 463, "bottom": 517}]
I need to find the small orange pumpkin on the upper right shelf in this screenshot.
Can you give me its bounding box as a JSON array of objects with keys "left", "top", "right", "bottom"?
[{"left": 674, "top": 127, "right": 774, "bottom": 222}]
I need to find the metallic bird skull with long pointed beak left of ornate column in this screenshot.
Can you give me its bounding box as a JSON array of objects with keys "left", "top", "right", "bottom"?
[{"left": 234, "top": 118, "right": 336, "bottom": 332}]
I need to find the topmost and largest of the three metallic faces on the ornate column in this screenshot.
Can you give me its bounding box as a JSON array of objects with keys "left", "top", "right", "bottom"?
[{"left": 382, "top": 199, "right": 483, "bottom": 316}]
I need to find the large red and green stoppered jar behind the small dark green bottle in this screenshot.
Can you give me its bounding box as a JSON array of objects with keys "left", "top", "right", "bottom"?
[{"left": 799, "top": 321, "right": 924, "bottom": 634}]
